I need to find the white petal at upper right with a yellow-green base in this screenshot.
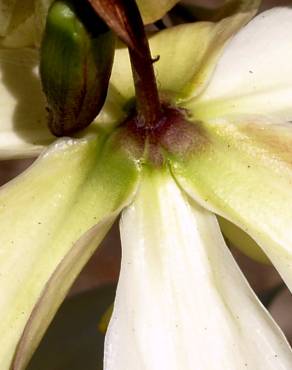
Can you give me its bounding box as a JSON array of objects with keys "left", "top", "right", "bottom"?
[{"left": 191, "top": 7, "right": 292, "bottom": 120}]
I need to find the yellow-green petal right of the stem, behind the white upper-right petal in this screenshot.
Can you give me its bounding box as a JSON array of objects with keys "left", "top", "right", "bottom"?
[{"left": 150, "top": 11, "right": 254, "bottom": 99}]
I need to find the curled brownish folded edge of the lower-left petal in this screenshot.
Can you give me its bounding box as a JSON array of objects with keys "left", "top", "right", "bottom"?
[{"left": 13, "top": 220, "right": 112, "bottom": 370}]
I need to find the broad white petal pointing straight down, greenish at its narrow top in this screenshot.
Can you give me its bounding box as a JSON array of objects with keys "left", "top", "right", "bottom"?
[{"left": 104, "top": 172, "right": 292, "bottom": 370}]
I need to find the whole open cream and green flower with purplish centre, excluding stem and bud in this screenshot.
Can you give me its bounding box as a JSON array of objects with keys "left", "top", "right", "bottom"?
[{"left": 0, "top": 1, "right": 292, "bottom": 370}]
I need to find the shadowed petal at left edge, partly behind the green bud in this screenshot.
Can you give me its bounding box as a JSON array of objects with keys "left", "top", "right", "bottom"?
[{"left": 0, "top": 49, "right": 53, "bottom": 159}]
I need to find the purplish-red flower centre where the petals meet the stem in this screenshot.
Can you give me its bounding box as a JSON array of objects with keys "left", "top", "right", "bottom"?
[{"left": 121, "top": 103, "right": 208, "bottom": 167}]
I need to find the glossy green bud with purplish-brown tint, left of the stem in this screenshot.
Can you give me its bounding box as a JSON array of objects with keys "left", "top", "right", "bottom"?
[{"left": 40, "top": 0, "right": 115, "bottom": 136}]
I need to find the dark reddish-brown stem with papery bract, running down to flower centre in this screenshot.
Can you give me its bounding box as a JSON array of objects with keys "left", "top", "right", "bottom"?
[{"left": 88, "top": 0, "right": 162, "bottom": 130}]
